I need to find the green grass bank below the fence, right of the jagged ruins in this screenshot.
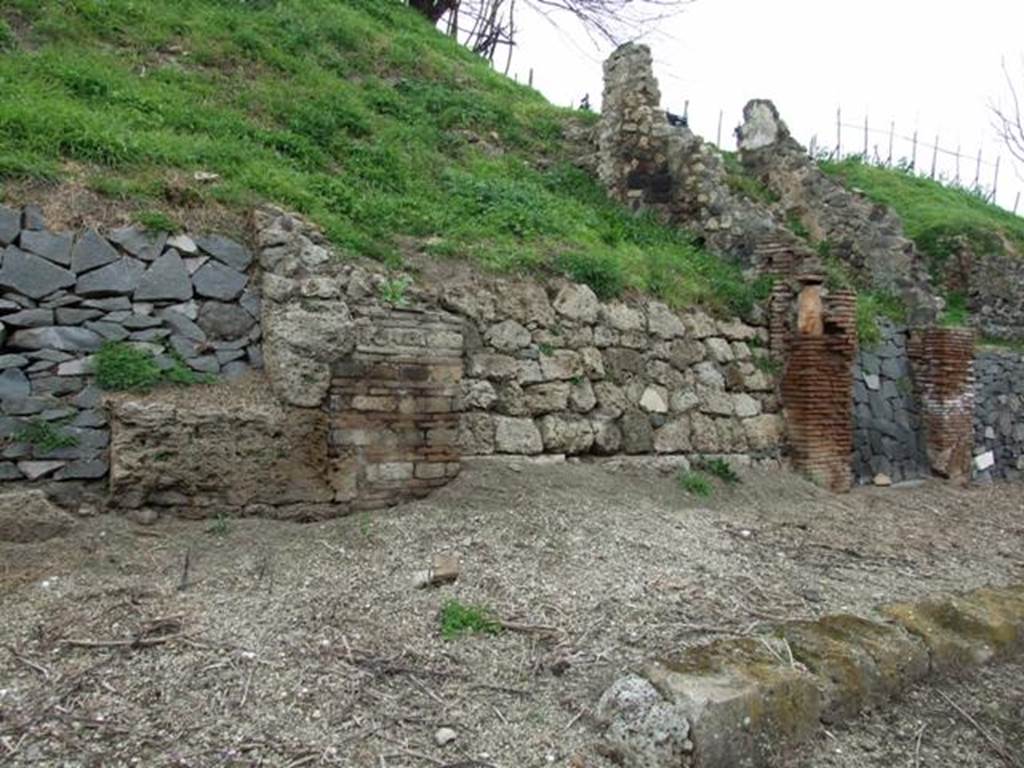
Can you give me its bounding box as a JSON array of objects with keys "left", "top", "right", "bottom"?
[{"left": 821, "top": 159, "right": 1024, "bottom": 287}]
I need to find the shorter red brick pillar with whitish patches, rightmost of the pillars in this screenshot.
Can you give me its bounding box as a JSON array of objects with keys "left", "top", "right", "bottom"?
[{"left": 907, "top": 328, "right": 974, "bottom": 481}]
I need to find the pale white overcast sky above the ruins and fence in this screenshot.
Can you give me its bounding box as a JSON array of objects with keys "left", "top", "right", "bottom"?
[{"left": 501, "top": 0, "right": 1024, "bottom": 214}]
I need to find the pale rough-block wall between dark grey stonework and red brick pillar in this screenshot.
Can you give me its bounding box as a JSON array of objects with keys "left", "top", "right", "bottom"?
[{"left": 258, "top": 213, "right": 782, "bottom": 475}]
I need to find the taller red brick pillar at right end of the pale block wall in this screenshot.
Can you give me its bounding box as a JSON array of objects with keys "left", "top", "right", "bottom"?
[{"left": 782, "top": 286, "right": 857, "bottom": 493}]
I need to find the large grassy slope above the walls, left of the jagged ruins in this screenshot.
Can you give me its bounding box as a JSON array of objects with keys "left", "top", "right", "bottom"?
[{"left": 0, "top": 0, "right": 770, "bottom": 310}]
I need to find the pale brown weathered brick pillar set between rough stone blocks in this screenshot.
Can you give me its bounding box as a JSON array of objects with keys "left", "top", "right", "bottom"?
[{"left": 328, "top": 310, "right": 463, "bottom": 509}]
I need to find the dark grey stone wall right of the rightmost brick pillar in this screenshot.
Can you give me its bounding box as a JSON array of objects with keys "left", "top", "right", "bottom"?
[{"left": 974, "top": 349, "right": 1024, "bottom": 480}]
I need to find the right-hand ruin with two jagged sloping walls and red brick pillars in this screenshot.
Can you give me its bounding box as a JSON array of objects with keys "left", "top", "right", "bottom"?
[{"left": 592, "top": 44, "right": 1024, "bottom": 490}]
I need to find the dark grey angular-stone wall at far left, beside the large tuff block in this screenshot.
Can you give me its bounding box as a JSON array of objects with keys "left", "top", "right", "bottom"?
[{"left": 0, "top": 202, "right": 262, "bottom": 480}]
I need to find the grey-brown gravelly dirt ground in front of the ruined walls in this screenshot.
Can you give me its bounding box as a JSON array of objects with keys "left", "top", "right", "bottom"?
[{"left": 6, "top": 464, "right": 1024, "bottom": 768}]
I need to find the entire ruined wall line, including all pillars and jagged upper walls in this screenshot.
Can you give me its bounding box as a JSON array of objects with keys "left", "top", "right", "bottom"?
[{"left": 0, "top": 45, "right": 1024, "bottom": 520}]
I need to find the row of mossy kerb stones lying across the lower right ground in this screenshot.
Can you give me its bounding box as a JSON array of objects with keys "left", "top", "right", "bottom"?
[{"left": 597, "top": 585, "right": 1024, "bottom": 768}]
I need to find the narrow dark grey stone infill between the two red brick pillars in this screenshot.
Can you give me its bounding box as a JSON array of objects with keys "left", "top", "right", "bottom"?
[{"left": 853, "top": 324, "right": 928, "bottom": 483}]
